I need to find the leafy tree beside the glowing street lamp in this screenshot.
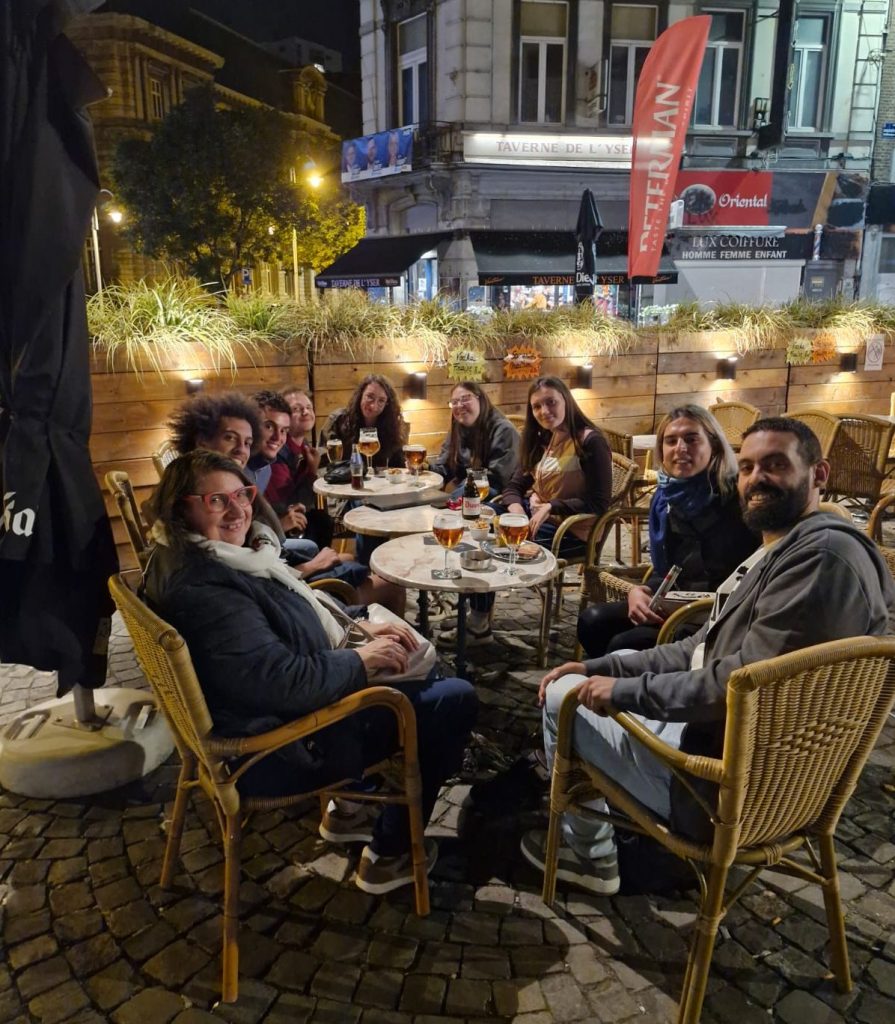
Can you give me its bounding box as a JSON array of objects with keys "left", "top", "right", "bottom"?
[{"left": 113, "top": 88, "right": 364, "bottom": 284}]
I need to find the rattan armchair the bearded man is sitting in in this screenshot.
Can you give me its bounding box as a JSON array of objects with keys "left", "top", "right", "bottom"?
[{"left": 543, "top": 637, "right": 895, "bottom": 1024}]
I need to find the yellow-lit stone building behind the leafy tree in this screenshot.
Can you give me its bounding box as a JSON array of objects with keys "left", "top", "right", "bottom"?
[{"left": 66, "top": 0, "right": 339, "bottom": 295}]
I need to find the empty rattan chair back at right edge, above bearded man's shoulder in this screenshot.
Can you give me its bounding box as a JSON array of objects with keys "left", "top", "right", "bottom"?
[{"left": 825, "top": 415, "right": 895, "bottom": 512}]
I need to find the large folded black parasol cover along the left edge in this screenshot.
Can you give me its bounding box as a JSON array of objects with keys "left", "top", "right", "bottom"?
[{"left": 0, "top": 0, "right": 118, "bottom": 694}]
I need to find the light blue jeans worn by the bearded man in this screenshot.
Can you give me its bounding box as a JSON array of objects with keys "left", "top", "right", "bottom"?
[{"left": 544, "top": 675, "right": 686, "bottom": 859}]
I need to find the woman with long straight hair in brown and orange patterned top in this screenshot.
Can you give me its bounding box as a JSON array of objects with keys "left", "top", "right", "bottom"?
[{"left": 450, "top": 377, "right": 612, "bottom": 642}]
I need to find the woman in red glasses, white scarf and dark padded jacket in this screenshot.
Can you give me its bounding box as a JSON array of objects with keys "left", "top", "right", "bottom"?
[{"left": 143, "top": 451, "right": 477, "bottom": 894}]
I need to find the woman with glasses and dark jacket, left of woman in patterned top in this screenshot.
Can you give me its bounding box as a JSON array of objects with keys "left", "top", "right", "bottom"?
[{"left": 432, "top": 381, "right": 519, "bottom": 498}]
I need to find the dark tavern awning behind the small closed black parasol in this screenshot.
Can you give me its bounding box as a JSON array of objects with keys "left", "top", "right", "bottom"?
[{"left": 469, "top": 230, "right": 678, "bottom": 285}]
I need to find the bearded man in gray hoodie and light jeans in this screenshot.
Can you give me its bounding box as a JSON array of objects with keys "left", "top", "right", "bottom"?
[{"left": 522, "top": 417, "right": 895, "bottom": 895}]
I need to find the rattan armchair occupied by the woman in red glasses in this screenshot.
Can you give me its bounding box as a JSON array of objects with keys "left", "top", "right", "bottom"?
[{"left": 109, "top": 575, "right": 429, "bottom": 1002}]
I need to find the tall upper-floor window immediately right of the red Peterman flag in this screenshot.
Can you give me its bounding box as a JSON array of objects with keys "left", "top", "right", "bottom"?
[{"left": 693, "top": 10, "right": 745, "bottom": 128}]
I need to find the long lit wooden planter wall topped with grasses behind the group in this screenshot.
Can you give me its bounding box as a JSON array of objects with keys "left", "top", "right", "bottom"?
[{"left": 90, "top": 333, "right": 895, "bottom": 567}]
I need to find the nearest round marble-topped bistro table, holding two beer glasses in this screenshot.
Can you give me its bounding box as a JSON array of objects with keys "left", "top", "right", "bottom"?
[{"left": 370, "top": 531, "right": 557, "bottom": 676}]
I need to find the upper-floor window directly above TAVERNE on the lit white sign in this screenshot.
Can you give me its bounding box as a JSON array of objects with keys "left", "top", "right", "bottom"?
[{"left": 519, "top": 0, "right": 568, "bottom": 124}]
